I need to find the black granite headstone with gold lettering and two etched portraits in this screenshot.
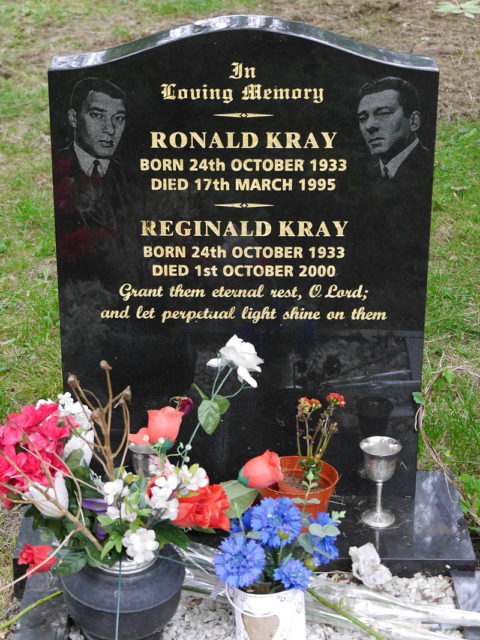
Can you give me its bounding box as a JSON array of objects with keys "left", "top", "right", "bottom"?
[{"left": 49, "top": 16, "right": 438, "bottom": 497}]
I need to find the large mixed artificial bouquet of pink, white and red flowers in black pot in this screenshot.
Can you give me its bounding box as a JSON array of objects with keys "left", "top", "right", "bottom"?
[{"left": 0, "top": 336, "right": 263, "bottom": 575}]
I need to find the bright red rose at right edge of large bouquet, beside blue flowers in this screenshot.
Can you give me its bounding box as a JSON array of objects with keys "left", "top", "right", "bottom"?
[{"left": 173, "top": 484, "right": 230, "bottom": 531}]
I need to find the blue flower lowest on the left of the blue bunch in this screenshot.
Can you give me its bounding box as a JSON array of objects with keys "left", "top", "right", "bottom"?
[{"left": 213, "top": 533, "right": 266, "bottom": 588}]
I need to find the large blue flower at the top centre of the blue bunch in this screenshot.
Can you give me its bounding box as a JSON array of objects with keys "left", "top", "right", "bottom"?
[{"left": 250, "top": 498, "right": 302, "bottom": 549}]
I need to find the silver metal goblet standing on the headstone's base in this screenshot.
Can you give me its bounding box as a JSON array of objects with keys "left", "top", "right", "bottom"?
[{"left": 360, "top": 436, "right": 402, "bottom": 529}]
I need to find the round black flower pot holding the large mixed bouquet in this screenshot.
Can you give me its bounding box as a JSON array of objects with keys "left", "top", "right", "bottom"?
[{"left": 61, "top": 546, "right": 185, "bottom": 640}]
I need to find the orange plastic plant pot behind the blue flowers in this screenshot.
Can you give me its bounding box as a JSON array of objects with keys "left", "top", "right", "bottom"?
[{"left": 259, "top": 456, "right": 339, "bottom": 515}]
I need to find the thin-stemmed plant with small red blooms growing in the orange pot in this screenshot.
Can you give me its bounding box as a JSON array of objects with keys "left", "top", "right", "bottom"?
[{"left": 295, "top": 393, "right": 345, "bottom": 488}]
